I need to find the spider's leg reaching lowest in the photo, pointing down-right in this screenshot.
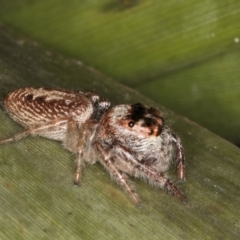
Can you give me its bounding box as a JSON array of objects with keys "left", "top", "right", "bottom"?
[{"left": 94, "top": 142, "right": 141, "bottom": 207}]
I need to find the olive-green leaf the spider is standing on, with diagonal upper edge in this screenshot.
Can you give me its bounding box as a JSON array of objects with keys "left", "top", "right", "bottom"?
[{"left": 0, "top": 25, "right": 240, "bottom": 240}]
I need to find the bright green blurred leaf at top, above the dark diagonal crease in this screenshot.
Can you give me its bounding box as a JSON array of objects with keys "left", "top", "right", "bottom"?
[{"left": 0, "top": 0, "right": 240, "bottom": 81}]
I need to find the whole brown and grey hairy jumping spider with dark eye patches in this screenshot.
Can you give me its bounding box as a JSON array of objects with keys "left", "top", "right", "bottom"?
[{"left": 0, "top": 88, "right": 185, "bottom": 206}]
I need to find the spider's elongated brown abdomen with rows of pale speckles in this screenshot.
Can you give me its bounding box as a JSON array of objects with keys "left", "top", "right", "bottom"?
[{"left": 4, "top": 88, "right": 94, "bottom": 128}]
